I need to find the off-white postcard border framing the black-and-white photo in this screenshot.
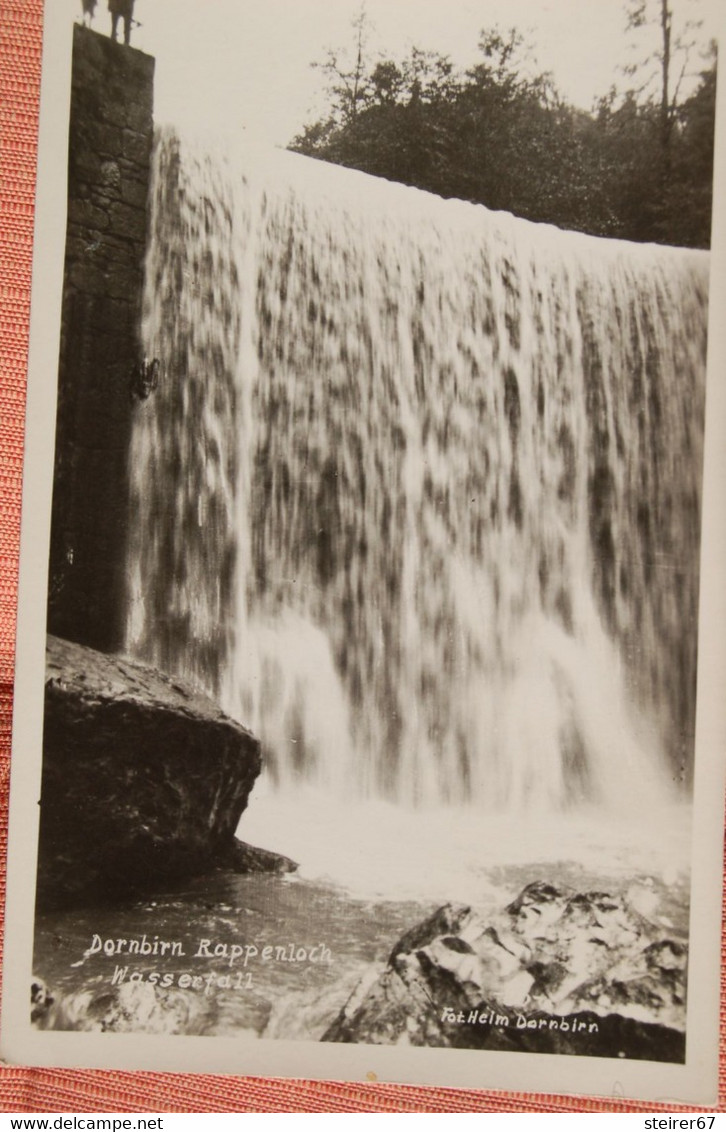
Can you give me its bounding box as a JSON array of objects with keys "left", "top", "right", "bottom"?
[{"left": 0, "top": 0, "right": 726, "bottom": 1106}]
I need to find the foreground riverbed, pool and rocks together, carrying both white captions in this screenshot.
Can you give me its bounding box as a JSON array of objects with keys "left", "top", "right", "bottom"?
[{"left": 33, "top": 873, "right": 687, "bottom": 1062}]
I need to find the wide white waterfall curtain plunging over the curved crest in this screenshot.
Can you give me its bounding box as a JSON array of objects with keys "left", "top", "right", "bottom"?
[{"left": 127, "top": 130, "right": 708, "bottom": 812}]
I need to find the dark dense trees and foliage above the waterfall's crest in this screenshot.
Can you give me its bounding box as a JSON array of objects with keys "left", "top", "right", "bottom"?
[{"left": 291, "top": 16, "right": 716, "bottom": 247}]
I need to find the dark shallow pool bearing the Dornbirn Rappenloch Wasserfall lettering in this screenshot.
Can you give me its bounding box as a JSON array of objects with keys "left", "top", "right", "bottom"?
[{"left": 34, "top": 873, "right": 434, "bottom": 1038}]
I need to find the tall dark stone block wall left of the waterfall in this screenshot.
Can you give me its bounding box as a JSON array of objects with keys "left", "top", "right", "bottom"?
[{"left": 49, "top": 26, "right": 154, "bottom": 652}]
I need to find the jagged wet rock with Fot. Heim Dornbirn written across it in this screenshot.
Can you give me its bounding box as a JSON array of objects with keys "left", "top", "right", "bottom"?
[{"left": 323, "top": 882, "right": 687, "bottom": 1062}]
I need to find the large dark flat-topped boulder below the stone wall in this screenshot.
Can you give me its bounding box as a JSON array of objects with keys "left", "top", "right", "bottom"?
[{"left": 37, "top": 637, "right": 260, "bottom": 906}]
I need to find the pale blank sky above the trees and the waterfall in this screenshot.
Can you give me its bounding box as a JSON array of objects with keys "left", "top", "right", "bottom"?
[{"left": 94, "top": 0, "right": 723, "bottom": 145}]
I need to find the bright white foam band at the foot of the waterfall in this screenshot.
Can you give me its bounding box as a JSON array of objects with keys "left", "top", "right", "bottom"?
[{"left": 238, "top": 782, "right": 691, "bottom": 901}]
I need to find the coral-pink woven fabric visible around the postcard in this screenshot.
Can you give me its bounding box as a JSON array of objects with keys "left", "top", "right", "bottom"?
[{"left": 0, "top": 0, "right": 726, "bottom": 1113}]
